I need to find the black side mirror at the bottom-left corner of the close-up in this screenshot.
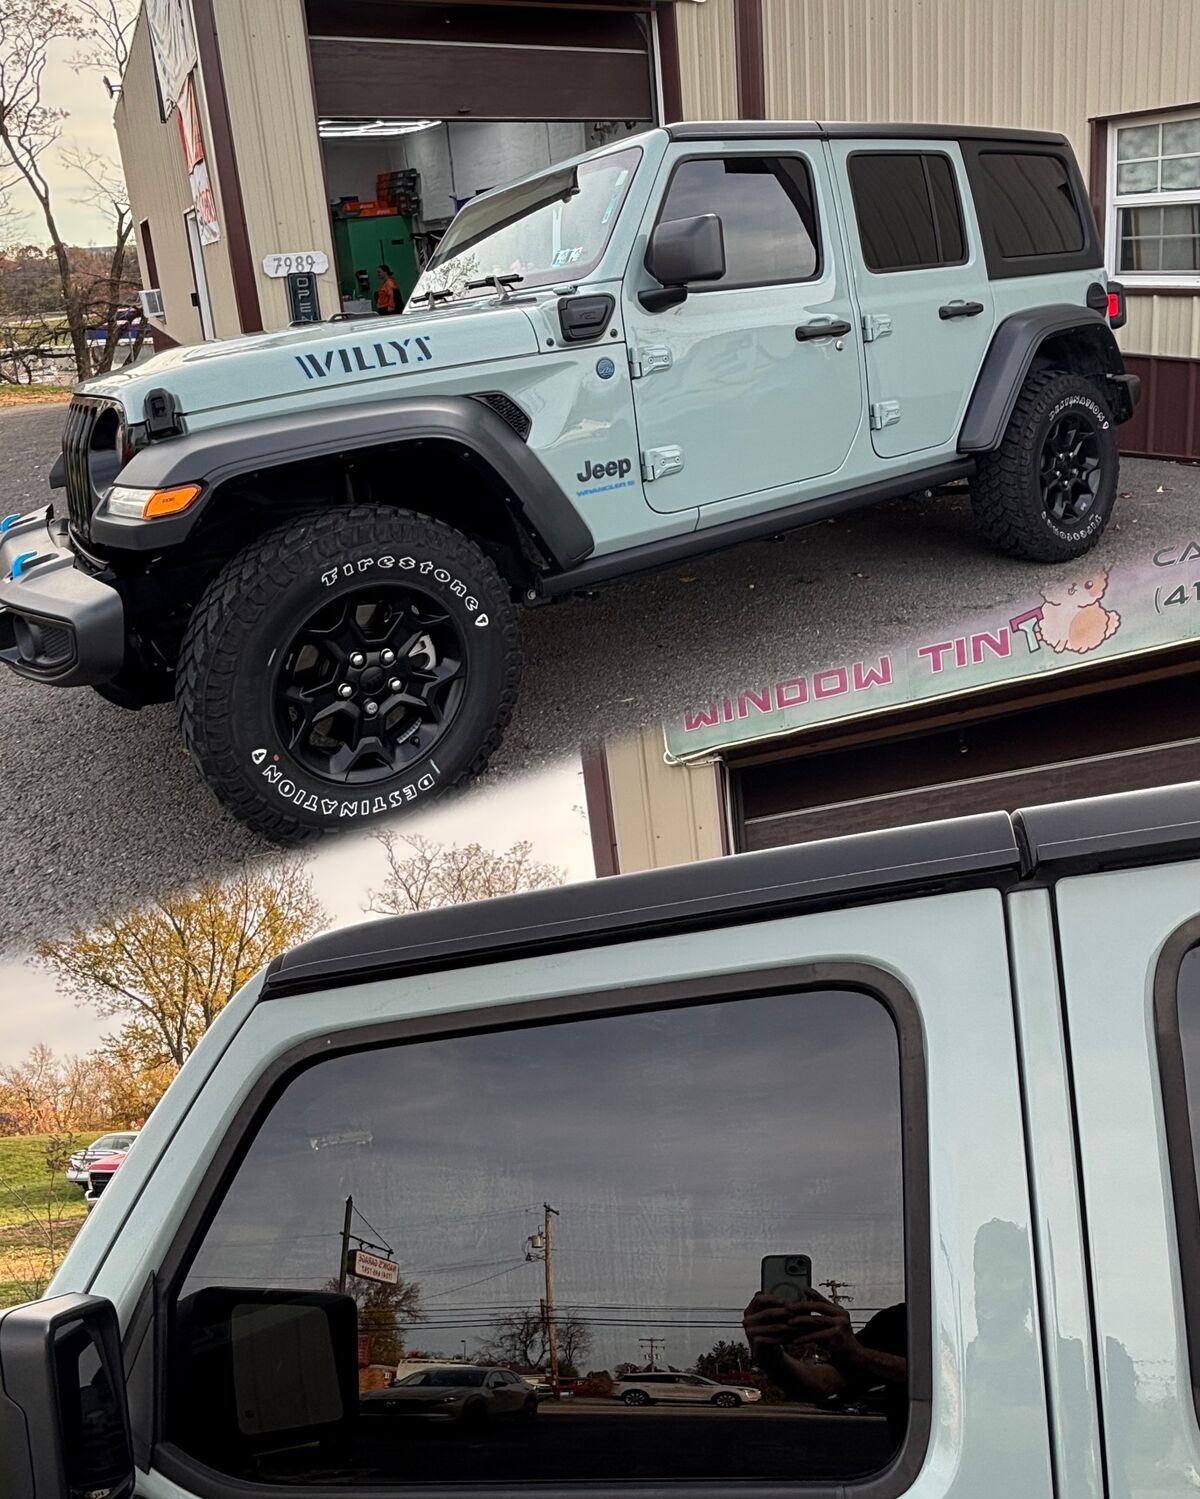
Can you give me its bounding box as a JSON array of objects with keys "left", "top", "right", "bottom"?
[{"left": 0, "top": 1295, "right": 136, "bottom": 1499}]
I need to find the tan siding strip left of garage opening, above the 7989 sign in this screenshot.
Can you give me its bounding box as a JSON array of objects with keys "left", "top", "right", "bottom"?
[{"left": 216, "top": 0, "right": 342, "bottom": 328}]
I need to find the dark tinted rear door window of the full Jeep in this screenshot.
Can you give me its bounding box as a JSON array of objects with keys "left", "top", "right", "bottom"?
[{"left": 849, "top": 151, "right": 966, "bottom": 271}]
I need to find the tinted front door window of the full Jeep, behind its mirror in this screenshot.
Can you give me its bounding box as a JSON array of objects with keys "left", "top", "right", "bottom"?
[{"left": 659, "top": 156, "right": 819, "bottom": 291}]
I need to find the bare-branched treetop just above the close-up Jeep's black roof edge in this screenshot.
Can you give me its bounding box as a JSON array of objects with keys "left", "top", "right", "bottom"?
[{"left": 364, "top": 829, "right": 566, "bottom": 916}]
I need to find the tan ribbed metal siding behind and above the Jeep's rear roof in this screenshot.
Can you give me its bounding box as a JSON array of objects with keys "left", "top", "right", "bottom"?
[{"left": 749, "top": 0, "right": 1200, "bottom": 357}]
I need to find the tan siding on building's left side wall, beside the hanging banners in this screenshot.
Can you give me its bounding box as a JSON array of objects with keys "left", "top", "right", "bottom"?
[{"left": 114, "top": 16, "right": 240, "bottom": 343}]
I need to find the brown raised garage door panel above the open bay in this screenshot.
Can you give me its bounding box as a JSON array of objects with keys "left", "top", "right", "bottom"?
[{"left": 299, "top": 0, "right": 656, "bottom": 121}]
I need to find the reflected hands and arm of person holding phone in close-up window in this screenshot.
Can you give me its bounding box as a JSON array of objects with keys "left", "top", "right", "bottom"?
[{"left": 742, "top": 1289, "right": 908, "bottom": 1447}]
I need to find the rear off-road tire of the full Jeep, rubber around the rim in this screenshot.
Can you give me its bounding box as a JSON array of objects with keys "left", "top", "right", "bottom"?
[{"left": 971, "top": 370, "right": 1119, "bottom": 562}]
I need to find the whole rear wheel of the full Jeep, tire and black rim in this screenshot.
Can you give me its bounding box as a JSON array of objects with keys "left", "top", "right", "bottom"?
[{"left": 971, "top": 370, "right": 1119, "bottom": 562}]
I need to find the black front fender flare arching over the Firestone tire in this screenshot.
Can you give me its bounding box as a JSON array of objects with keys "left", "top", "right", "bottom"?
[{"left": 91, "top": 396, "right": 595, "bottom": 570}]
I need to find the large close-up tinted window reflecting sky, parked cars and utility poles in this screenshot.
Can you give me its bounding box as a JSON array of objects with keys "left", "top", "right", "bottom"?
[{"left": 169, "top": 991, "right": 909, "bottom": 1486}]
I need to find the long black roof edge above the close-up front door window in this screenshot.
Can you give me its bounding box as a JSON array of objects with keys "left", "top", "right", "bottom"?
[{"left": 261, "top": 812, "right": 1023, "bottom": 1000}]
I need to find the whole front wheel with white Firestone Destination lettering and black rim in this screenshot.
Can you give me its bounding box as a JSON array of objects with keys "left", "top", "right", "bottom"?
[{"left": 175, "top": 507, "right": 521, "bottom": 844}]
